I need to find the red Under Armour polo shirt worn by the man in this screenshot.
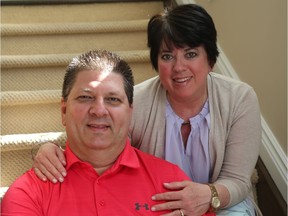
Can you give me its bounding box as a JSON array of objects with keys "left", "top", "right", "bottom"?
[{"left": 1, "top": 141, "right": 214, "bottom": 216}]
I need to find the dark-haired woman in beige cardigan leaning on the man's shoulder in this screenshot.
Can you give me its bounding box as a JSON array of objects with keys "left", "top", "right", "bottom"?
[{"left": 34, "top": 4, "right": 261, "bottom": 216}]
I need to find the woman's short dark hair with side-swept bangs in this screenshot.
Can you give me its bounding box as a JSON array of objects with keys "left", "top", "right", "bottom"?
[{"left": 148, "top": 4, "right": 219, "bottom": 71}]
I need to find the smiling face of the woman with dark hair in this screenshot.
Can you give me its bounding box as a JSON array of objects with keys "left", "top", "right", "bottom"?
[{"left": 158, "top": 43, "right": 212, "bottom": 101}]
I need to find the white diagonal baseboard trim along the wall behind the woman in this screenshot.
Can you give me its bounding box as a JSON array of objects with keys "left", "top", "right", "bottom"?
[{"left": 217, "top": 45, "right": 288, "bottom": 202}]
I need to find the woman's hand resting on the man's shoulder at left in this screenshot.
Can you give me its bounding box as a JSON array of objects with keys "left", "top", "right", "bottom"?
[{"left": 33, "top": 142, "right": 67, "bottom": 183}]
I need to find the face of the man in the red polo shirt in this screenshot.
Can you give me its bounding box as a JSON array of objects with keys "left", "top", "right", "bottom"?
[{"left": 61, "top": 70, "right": 132, "bottom": 160}]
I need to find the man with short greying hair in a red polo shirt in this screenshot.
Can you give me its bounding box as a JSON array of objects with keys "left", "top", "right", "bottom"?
[{"left": 1, "top": 50, "right": 214, "bottom": 216}]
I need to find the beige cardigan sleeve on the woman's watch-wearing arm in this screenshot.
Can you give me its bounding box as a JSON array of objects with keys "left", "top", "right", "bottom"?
[{"left": 215, "top": 88, "right": 261, "bottom": 207}]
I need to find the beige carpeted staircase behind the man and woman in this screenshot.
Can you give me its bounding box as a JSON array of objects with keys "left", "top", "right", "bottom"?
[{"left": 0, "top": 1, "right": 163, "bottom": 191}]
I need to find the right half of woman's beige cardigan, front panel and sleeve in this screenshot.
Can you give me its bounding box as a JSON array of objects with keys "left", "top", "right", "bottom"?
[{"left": 209, "top": 75, "right": 261, "bottom": 207}]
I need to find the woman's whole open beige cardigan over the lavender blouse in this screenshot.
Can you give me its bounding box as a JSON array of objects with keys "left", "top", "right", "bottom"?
[{"left": 130, "top": 72, "right": 261, "bottom": 207}]
